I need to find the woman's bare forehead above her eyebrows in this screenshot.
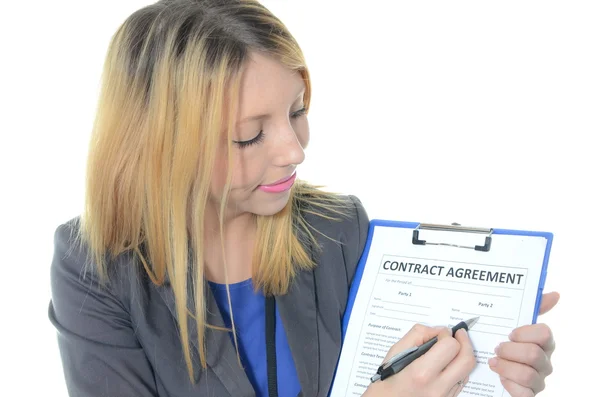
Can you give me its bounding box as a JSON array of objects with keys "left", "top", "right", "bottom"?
[{"left": 238, "top": 53, "right": 305, "bottom": 118}]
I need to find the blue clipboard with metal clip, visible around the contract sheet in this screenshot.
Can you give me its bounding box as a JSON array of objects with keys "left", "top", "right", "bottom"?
[{"left": 342, "top": 219, "right": 554, "bottom": 341}]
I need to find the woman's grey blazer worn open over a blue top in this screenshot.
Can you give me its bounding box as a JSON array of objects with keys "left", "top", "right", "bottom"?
[{"left": 48, "top": 196, "right": 369, "bottom": 397}]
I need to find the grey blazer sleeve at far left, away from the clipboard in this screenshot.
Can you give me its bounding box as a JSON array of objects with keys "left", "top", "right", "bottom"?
[{"left": 48, "top": 224, "right": 158, "bottom": 397}]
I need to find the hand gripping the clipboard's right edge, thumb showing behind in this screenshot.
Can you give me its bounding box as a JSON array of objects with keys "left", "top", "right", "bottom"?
[{"left": 489, "top": 292, "right": 560, "bottom": 397}]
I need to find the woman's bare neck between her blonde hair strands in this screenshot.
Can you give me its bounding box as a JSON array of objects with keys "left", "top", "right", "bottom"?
[{"left": 198, "top": 203, "right": 256, "bottom": 284}]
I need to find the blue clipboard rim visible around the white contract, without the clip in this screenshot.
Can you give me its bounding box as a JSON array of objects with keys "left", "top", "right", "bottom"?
[{"left": 342, "top": 219, "right": 554, "bottom": 341}]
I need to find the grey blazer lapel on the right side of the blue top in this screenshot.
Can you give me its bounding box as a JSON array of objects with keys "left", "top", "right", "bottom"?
[{"left": 276, "top": 258, "right": 319, "bottom": 397}]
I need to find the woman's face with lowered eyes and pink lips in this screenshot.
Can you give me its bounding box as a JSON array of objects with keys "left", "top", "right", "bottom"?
[{"left": 211, "top": 54, "right": 309, "bottom": 216}]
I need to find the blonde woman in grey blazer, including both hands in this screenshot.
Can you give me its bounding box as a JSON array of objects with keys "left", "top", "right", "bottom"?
[{"left": 49, "top": 0, "right": 556, "bottom": 397}]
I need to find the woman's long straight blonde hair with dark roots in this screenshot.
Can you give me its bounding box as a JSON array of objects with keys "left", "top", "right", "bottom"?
[{"left": 74, "top": 0, "right": 348, "bottom": 381}]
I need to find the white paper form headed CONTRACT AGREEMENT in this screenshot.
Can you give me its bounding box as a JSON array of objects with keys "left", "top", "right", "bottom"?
[{"left": 331, "top": 226, "right": 548, "bottom": 397}]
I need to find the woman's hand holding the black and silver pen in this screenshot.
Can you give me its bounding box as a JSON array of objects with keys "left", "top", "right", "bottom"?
[{"left": 363, "top": 325, "right": 476, "bottom": 397}]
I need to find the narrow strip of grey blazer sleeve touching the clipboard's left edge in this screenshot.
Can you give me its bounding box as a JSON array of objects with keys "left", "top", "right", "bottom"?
[{"left": 342, "top": 195, "right": 369, "bottom": 287}]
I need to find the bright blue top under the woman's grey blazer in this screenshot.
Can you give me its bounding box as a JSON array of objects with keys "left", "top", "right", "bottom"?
[{"left": 208, "top": 279, "right": 300, "bottom": 397}]
